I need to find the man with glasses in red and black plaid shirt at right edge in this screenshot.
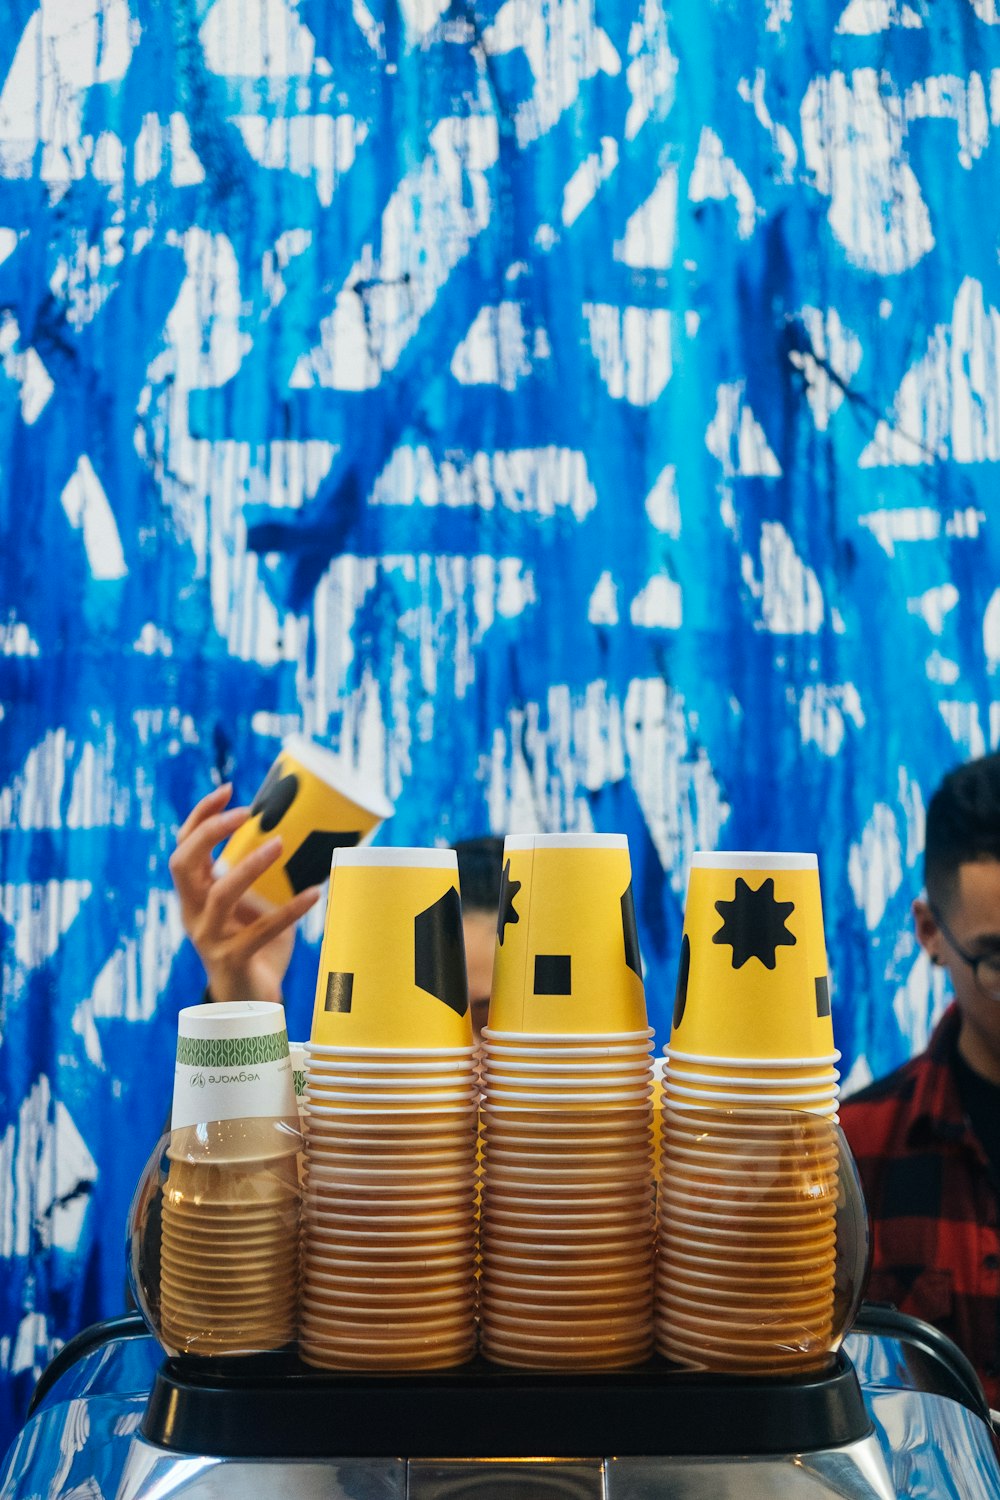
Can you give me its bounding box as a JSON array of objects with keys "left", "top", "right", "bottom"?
[{"left": 841, "top": 755, "right": 1000, "bottom": 1407}]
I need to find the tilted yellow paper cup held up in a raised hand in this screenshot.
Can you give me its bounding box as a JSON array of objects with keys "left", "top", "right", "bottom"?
[{"left": 216, "top": 735, "right": 393, "bottom": 908}]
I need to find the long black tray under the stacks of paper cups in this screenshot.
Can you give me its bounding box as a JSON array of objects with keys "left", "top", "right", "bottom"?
[{"left": 141, "top": 1352, "right": 871, "bottom": 1458}]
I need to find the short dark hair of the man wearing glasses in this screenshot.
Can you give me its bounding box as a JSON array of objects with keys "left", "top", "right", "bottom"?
[{"left": 924, "top": 755, "right": 1000, "bottom": 909}]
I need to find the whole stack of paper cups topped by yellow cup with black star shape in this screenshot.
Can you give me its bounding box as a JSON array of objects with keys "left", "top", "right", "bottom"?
[{"left": 655, "top": 854, "right": 844, "bottom": 1373}]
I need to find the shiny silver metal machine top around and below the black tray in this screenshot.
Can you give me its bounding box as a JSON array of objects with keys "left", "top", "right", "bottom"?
[{"left": 0, "top": 1334, "right": 1000, "bottom": 1500}]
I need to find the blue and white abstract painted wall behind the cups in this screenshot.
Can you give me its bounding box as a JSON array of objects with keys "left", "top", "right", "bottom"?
[{"left": 0, "top": 0, "right": 1000, "bottom": 1436}]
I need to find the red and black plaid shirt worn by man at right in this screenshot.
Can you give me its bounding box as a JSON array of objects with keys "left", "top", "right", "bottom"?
[{"left": 841, "top": 1005, "right": 1000, "bottom": 1407}]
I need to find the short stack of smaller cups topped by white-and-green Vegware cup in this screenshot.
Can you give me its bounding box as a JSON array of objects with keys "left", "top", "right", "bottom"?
[{"left": 159, "top": 1002, "right": 303, "bottom": 1355}]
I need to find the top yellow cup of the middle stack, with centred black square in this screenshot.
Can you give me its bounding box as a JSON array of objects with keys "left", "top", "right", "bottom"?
[{"left": 489, "top": 834, "right": 646, "bottom": 1040}]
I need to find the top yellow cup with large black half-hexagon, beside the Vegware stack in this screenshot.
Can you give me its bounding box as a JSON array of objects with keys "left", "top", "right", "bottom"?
[{"left": 312, "top": 849, "right": 472, "bottom": 1050}]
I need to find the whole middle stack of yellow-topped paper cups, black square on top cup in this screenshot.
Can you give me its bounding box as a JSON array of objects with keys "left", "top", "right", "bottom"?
[{"left": 480, "top": 834, "right": 654, "bottom": 1370}]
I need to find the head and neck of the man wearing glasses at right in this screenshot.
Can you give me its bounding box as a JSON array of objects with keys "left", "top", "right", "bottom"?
[{"left": 913, "top": 755, "right": 1000, "bottom": 1083}]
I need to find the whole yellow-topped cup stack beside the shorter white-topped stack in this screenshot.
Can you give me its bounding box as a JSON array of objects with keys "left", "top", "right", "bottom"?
[{"left": 300, "top": 849, "right": 478, "bottom": 1370}]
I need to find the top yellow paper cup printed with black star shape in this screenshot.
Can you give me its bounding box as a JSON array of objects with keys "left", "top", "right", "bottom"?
[{"left": 670, "top": 854, "right": 834, "bottom": 1061}]
